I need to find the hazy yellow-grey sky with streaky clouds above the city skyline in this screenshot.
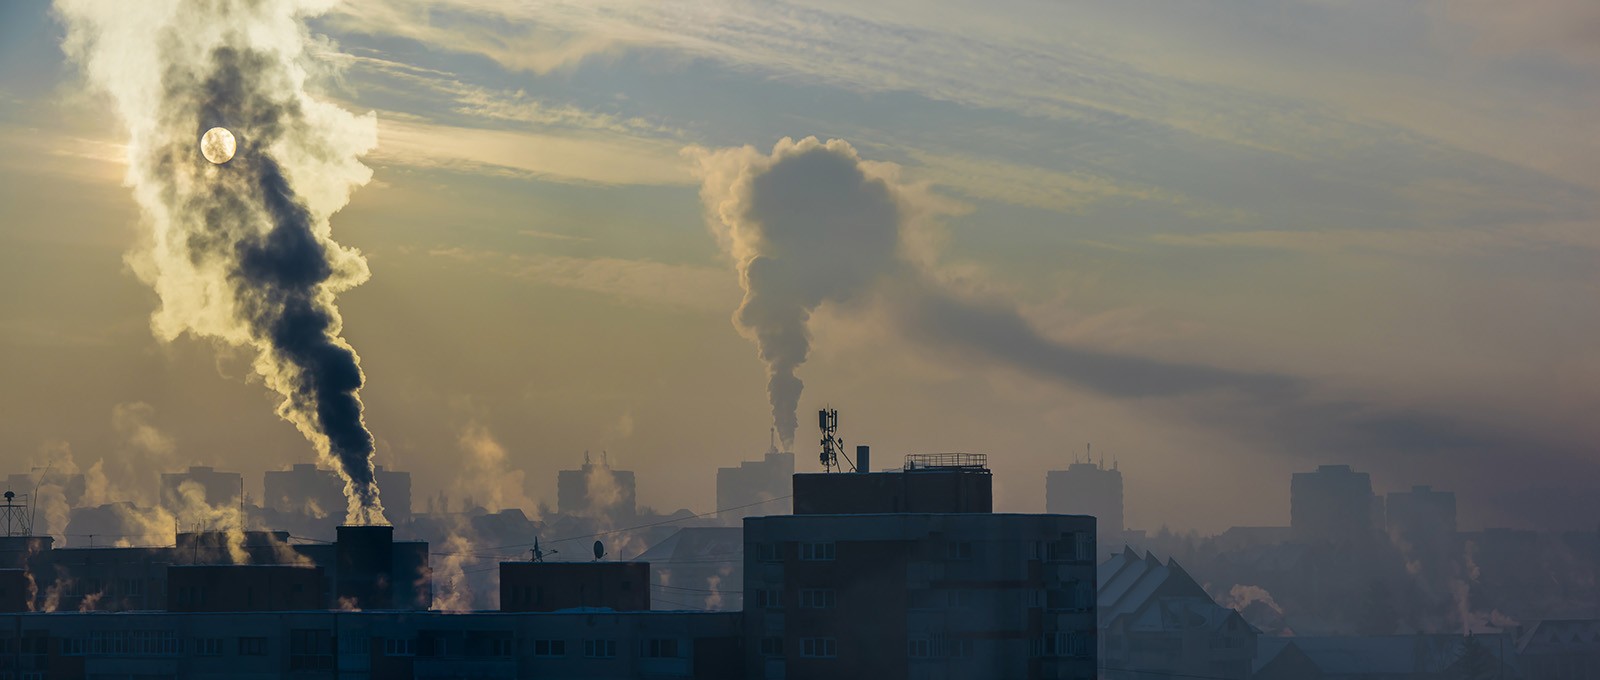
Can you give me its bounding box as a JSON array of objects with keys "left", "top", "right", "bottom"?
[{"left": 0, "top": 0, "right": 1600, "bottom": 533}]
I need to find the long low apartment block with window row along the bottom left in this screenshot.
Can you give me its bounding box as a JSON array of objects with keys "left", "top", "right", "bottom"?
[{"left": 0, "top": 611, "right": 741, "bottom": 680}]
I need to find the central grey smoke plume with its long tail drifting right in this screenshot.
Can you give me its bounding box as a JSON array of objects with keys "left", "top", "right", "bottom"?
[{"left": 686, "top": 138, "right": 1555, "bottom": 467}]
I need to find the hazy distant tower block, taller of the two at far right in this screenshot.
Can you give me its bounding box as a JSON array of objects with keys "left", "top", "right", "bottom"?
[{"left": 1290, "top": 466, "right": 1384, "bottom": 546}]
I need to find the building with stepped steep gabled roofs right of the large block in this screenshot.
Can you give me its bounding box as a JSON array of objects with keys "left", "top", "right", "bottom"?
[{"left": 1096, "top": 547, "right": 1258, "bottom": 680}]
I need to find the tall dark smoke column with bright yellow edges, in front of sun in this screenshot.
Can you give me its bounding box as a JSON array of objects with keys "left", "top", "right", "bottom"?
[{"left": 56, "top": 0, "right": 384, "bottom": 523}]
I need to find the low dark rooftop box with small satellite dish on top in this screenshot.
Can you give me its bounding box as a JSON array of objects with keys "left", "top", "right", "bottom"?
[{"left": 501, "top": 562, "right": 650, "bottom": 611}]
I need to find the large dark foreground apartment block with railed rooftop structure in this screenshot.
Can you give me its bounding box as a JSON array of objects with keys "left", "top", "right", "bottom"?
[{"left": 744, "top": 454, "right": 1096, "bottom": 680}]
